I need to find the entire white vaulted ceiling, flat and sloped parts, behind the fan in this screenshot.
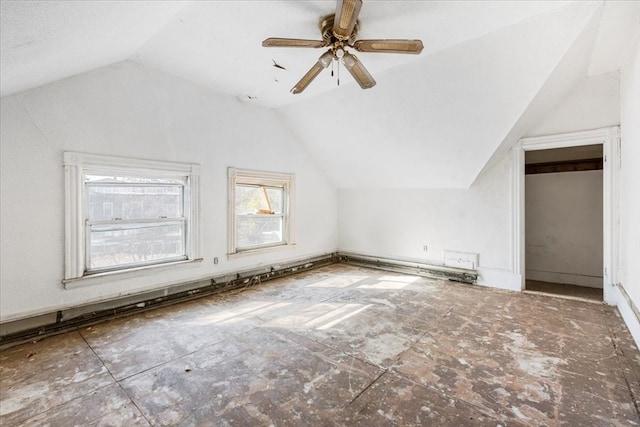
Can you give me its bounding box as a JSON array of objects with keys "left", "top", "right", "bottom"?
[{"left": 0, "top": 0, "right": 640, "bottom": 188}]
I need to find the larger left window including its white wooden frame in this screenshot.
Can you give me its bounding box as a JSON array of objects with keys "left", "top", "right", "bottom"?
[{"left": 65, "top": 153, "right": 199, "bottom": 280}]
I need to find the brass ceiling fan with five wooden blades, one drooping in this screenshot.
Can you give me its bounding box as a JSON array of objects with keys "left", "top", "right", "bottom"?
[{"left": 262, "top": 0, "right": 423, "bottom": 94}]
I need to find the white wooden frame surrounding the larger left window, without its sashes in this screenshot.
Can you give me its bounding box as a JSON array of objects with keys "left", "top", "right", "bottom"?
[{"left": 63, "top": 152, "right": 200, "bottom": 284}]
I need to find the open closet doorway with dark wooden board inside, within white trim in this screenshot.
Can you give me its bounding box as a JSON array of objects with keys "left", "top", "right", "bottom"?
[{"left": 524, "top": 144, "right": 604, "bottom": 301}]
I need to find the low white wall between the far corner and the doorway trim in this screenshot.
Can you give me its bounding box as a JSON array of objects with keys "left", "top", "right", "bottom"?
[{"left": 338, "top": 157, "right": 512, "bottom": 288}]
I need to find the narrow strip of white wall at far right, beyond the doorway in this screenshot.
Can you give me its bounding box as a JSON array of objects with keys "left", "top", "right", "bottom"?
[{"left": 618, "top": 35, "right": 640, "bottom": 346}]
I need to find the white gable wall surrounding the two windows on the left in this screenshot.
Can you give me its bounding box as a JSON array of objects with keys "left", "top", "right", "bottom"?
[{"left": 0, "top": 62, "right": 337, "bottom": 321}]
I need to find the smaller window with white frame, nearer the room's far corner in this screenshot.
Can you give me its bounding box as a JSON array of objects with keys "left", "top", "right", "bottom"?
[{"left": 229, "top": 168, "right": 295, "bottom": 255}]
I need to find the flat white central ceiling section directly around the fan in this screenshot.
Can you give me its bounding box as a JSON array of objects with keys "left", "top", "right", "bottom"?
[{"left": 133, "top": 0, "right": 576, "bottom": 107}]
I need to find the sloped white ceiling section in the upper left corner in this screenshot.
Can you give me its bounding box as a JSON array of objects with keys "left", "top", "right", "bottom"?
[{"left": 0, "top": 1, "right": 184, "bottom": 96}]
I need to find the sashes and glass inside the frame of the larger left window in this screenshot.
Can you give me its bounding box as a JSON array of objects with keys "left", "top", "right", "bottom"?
[{"left": 84, "top": 174, "right": 187, "bottom": 273}]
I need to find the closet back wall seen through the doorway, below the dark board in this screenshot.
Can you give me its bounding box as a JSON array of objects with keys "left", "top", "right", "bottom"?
[{"left": 525, "top": 170, "right": 603, "bottom": 288}]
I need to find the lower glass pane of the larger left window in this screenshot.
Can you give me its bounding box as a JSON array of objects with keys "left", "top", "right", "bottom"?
[{"left": 88, "top": 222, "right": 185, "bottom": 270}]
